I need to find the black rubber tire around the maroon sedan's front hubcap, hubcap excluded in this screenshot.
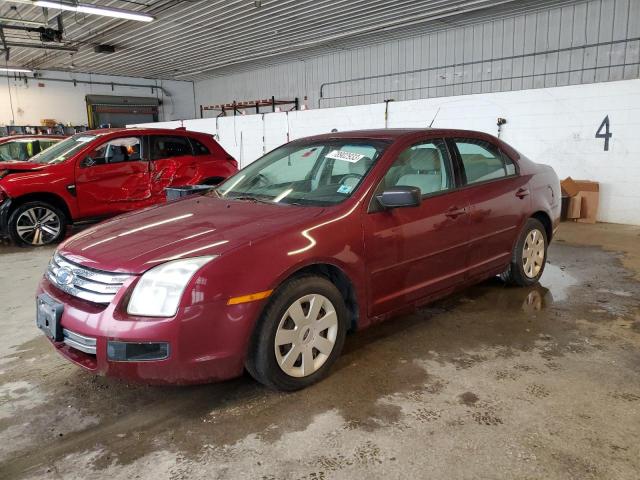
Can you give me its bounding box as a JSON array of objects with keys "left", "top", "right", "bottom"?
[{"left": 246, "top": 275, "right": 349, "bottom": 391}]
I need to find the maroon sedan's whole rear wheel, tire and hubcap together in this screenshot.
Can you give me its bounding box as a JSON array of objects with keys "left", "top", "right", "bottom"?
[{"left": 500, "top": 218, "right": 548, "bottom": 287}]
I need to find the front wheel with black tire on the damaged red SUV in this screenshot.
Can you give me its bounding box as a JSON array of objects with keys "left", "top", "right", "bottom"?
[{"left": 7, "top": 201, "right": 68, "bottom": 247}]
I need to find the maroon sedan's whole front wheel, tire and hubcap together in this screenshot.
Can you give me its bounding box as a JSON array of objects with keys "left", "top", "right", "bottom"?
[{"left": 246, "top": 276, "right": 348, "bottom": 391}]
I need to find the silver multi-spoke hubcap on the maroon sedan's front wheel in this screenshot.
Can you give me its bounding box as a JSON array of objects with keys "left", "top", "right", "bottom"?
[{"left": 274, "top": 294, "right": 338, "bottom": 378}]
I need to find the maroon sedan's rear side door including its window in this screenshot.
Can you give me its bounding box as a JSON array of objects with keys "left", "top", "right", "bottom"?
[{"left": 450, "top": 138, "right": 531, "bottom": 278}]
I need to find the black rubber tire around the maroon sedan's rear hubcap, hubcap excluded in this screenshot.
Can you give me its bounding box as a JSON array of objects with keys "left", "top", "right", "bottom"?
[{"left": 500, "top": 218, "right": 549, "bottom": 287}]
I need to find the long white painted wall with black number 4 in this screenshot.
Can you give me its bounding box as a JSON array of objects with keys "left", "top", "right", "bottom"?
[{"left": 131, "top": 79, "right": 640, "bottom": 225}]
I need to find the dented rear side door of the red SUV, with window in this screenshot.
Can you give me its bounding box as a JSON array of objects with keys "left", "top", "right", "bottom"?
[{"left": 149, "top": 135, "right": 198, "bottom": 201}]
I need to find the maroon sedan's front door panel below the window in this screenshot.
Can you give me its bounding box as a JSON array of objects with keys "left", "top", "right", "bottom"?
[{"left": 364, "top": 191, "right": 468, "bottom": 316}]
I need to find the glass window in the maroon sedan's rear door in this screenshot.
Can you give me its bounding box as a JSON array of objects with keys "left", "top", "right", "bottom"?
[{"left": 454, "top": 138, "right": 516, "bottom": 185}]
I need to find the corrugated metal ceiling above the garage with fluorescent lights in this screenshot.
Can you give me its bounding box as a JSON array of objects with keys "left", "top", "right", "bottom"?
[{"left": 0, "top": 0, "right": 540, "bottom": 80}]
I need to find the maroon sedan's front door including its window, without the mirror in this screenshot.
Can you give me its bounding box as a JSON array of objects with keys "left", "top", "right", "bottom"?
[{"left": 363, "top": 139, "right": 469, "bottom": 316}]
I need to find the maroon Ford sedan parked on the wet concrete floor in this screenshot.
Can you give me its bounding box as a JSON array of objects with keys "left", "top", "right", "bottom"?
[{"left": 37, "top": 129, "right": 560, "bottom": 390}]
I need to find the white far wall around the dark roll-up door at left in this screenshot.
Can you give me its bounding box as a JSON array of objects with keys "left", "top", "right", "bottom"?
[{"left": 0, "top": 71, "right": 196, "bottom": 125}]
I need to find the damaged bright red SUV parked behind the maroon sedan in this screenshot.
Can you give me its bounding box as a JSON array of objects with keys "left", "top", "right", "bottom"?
[{"left": 0, "top": 129, "right": 238, "bottom": 246}]
